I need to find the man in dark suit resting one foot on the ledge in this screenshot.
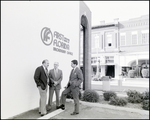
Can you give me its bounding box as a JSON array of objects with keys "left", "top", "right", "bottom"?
[{"left": 59, "top": 60, "right": 83, "bottom": 115}]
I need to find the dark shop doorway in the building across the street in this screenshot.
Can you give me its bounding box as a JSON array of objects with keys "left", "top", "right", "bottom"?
[{"left": 106, "top": 65, "right": 115, "bottom": 78}]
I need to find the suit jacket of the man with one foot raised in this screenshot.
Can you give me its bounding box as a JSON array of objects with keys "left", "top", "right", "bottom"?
[{"left": 67, "top": 67, "right": 83, "bottom": 88}]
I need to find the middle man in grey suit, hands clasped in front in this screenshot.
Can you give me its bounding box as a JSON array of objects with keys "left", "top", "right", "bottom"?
[{"left": 48, "top": 62, "right": 63, "bottom": 110}]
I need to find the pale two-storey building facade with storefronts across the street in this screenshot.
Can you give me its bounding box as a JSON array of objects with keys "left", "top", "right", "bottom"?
[{"left": 80, "top": 15, "right": 149, "bottom": 78}]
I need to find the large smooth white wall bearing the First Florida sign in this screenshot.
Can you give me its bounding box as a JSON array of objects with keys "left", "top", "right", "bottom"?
[{"left": 1, "top": 1, "right": 80, "bottom": 119}]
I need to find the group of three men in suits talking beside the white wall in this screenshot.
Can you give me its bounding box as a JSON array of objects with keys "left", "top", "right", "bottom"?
[{"left": 34, "top": 60, "right": 83, "bottom": 116}]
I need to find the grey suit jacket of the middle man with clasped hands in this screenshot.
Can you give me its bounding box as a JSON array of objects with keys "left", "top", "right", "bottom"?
[{"left": 49, "top": 69, "right": 63, "bottom": 89}]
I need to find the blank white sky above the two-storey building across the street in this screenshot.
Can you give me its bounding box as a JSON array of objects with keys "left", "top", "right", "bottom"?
[{"left": 84, "top": 1, "right": 149, "bottom": 26}]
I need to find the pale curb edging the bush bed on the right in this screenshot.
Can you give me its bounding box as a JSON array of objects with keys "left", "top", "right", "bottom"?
[{"left": 66, "top": 99, "right": 149, "bottom": 115}]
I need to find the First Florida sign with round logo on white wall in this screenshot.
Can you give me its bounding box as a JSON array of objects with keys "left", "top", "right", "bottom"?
[{"left": 41, "top": 27, "right": 73, "bottom": 55}]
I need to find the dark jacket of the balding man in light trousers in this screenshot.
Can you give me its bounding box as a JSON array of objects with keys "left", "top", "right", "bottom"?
[{"left": 34, "top": 66, "right": 48, "bottom": 90}]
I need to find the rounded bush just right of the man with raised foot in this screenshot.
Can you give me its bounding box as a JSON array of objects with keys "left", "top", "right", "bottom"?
[{"left": 83, "top": 90, "right": 99, "bottom": 102}]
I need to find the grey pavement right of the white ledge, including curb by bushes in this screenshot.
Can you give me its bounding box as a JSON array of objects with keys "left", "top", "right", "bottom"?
[{"left": 50, "top": 99, "right": 149, "bottom": 119}]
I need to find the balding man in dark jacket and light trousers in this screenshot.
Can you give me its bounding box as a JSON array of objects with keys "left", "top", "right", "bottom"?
[{"left": 34, "top": 60, "right": 49, "bottom": 116}]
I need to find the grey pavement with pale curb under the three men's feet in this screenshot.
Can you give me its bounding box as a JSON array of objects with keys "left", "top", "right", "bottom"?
[{"left": 11, "top": 91, "right": 149, "bottom": 119}]
